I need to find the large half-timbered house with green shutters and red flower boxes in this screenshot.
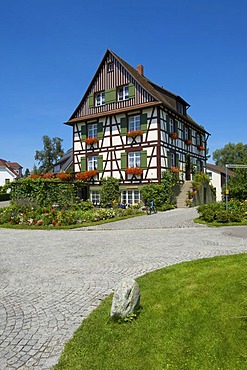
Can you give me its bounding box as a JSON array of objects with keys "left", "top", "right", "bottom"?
[{"left": 65, "top": 50, "right": 209, "bottom": 204}]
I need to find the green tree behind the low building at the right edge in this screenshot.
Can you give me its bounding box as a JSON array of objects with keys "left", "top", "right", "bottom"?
[{"left": 213, "top": 143, "right": 247, "bottom": 167}]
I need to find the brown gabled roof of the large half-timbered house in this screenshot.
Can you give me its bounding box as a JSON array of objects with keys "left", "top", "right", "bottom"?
[{"left": 68, "top": 49, "right": 209, "bottom": 134}]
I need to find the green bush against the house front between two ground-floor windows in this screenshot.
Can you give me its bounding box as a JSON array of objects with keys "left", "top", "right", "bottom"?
[{"left": 100, "top": 177, "right": 120, "bottom": 207}]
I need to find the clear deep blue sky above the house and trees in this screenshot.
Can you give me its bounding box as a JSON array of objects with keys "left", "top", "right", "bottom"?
[{"left": 0, "top": 0, "right": 247, "bottom": 170}]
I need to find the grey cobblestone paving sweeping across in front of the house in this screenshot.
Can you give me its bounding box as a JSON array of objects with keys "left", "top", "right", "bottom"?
[{"left": 0, "top": 209, "right": 247, "bottom": 370}]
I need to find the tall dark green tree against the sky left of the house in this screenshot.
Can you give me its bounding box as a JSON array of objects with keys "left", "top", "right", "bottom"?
[{"left": 34, "top": 135, "right": 64, "bottom": 173}]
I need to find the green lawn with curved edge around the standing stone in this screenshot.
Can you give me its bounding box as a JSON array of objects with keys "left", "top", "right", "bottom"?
[{"left": 54, "top": 254, "right": 247, "bottom": 370}]
